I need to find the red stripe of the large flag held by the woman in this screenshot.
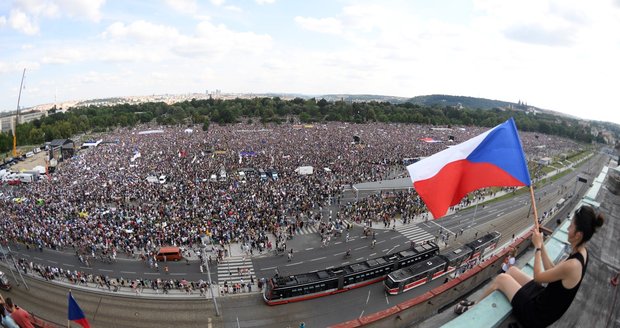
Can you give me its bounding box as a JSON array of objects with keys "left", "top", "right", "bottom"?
[{"left": 413, "top": 159, "right": 524, "bottom": 218}]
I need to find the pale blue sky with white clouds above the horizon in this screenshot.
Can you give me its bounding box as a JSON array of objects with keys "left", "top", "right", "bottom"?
[{"left": 0, "top": 0, "right": 620, "bottom": 123}]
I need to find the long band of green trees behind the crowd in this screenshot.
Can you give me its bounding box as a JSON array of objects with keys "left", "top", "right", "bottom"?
[{"left": 0, "top": 97, "right": 620, "bottom": 152}]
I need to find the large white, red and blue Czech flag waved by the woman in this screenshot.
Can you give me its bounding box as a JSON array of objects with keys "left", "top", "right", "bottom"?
[{"left": 407, "top": 118, "right": 531, "bottom": 219}]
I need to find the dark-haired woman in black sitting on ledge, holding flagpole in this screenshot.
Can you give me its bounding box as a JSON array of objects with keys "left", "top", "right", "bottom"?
[{"left": 468, "top": 205, "right": 604, "bottom": 327}]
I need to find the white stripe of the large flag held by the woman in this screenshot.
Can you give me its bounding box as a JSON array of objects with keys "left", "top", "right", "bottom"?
[{"left": 407, "top": 127, "right": 497, "bottom": 183}]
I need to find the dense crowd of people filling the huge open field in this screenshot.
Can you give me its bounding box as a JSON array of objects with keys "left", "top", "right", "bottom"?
[{"left": 0, "top": 123, "right": 578, "bottom": 254}]
